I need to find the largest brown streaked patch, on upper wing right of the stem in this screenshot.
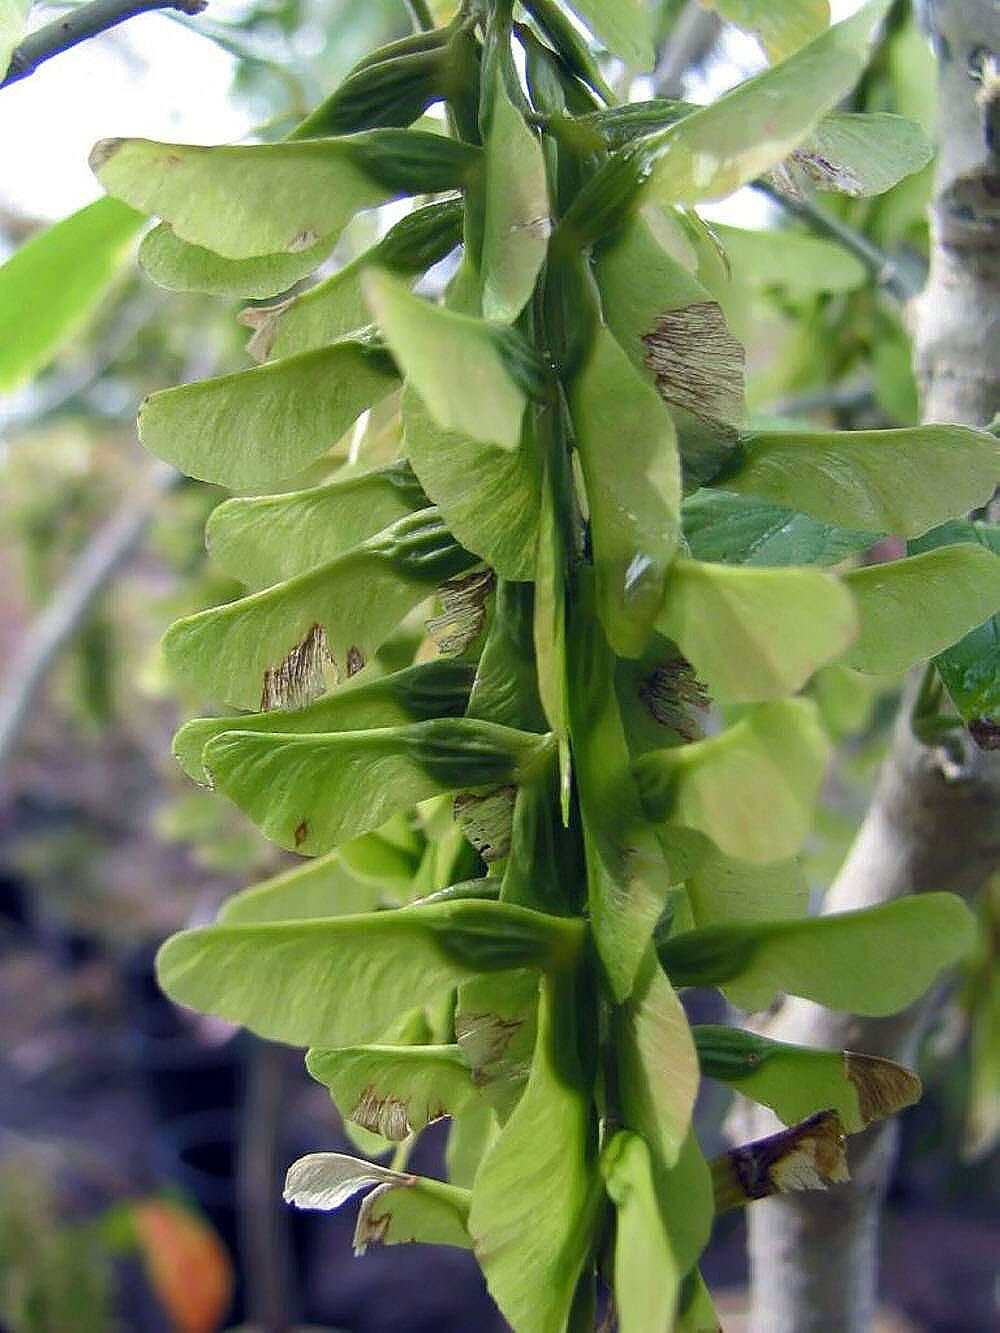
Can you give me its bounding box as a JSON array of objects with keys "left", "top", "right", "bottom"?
[{"left": 643, "top": 301, "right": 744, "bottom": 427}]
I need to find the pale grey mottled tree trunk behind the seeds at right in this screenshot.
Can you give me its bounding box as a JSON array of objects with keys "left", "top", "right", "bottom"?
[{"left": 733, "top": 0, "right": 1000, "bottom": 1333}]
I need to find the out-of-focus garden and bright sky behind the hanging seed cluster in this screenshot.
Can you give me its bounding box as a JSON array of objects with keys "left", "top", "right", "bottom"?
[{"left": 0, "top": 0, "right": 1000, "bottom": 1333}]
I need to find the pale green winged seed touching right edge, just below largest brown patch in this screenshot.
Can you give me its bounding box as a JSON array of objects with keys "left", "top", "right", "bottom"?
[{"left": 723, "top": 425, "right": 1000, "bottom": 537}]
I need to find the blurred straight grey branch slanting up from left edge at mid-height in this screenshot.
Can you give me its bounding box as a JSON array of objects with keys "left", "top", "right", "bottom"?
[{"left": 0, "top": 463, "right": 180, "bottom": 768}]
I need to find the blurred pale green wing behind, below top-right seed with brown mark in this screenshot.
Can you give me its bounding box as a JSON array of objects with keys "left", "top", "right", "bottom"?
[{"left": 712, "top": 221, "right": 868, "bottom": 301}]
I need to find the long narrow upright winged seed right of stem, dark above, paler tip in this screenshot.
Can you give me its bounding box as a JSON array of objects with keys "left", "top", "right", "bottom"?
[{"left": 568, "top": 594, "right": 671, "bottom": 1002}]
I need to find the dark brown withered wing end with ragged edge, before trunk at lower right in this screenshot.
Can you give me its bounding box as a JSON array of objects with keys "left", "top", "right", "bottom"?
[{"left": 709, "top": 1110, "right": 849, "bottom": 1213}]
